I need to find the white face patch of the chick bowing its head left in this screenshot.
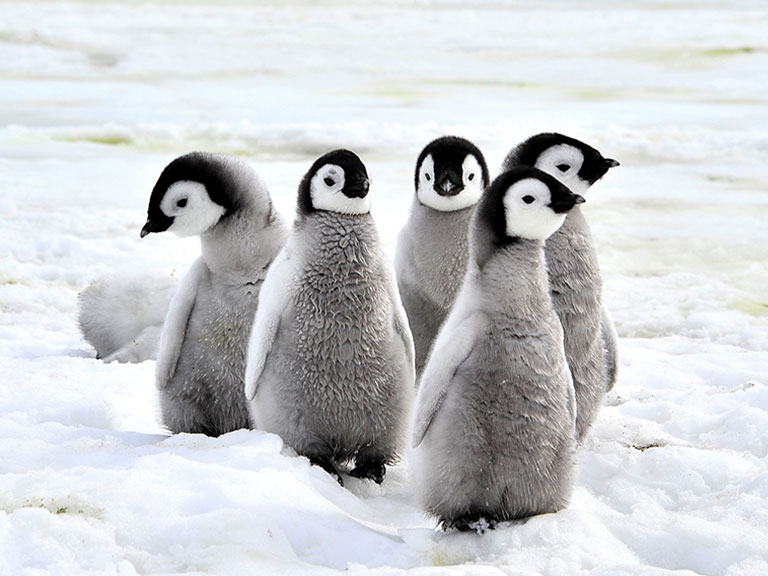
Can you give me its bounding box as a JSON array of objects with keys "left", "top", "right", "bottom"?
[{"left": 160, "top": 180, "right": 226, "bottom": 237}]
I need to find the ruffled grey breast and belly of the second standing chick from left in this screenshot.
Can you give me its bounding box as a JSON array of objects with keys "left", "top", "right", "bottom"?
[{"left": 252, "top": 216, "right": 412, "bottom": 462}]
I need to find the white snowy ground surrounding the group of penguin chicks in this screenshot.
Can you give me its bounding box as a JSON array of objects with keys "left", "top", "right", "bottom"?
[{"left": 0, "top": 0, "right": 768, "bottom": 576}]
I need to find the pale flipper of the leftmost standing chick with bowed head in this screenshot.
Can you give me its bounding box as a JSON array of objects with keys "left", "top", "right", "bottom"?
[{"left": 155, "top": 258, "right": 207, "bottom": 390}]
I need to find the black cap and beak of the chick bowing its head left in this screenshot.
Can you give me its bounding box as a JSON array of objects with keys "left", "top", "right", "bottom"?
[{"left": 141, "top": 152, "right": 240, "bottom": 238}]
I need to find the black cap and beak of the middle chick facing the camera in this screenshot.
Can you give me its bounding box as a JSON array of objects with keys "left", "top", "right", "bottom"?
[{"left": 414, "top": 136, "right": 490, "bottom": 196}]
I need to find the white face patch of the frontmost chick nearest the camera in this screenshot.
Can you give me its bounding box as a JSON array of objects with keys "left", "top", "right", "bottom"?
[{"left": 504, "top": 178, "right": 565, "bottom": 240}]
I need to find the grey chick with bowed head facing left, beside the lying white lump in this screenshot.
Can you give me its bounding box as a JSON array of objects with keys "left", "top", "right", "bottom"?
[{"left": 141, "top": 152, "right": 288, "bottom": 436}]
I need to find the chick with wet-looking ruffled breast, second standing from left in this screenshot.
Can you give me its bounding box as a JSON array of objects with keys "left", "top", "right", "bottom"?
[{"left": 245, "top": 150, "right": 414, "bottom": 483}]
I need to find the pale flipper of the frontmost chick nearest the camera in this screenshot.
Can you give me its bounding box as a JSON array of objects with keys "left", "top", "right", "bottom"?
[{"left": 413, "top": 314, "right": 478, "bottom": 448}]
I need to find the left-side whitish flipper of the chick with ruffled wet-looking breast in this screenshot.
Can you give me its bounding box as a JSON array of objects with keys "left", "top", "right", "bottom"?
[{"left": 245, "top": 245, "right": 296, "bottom": 400}]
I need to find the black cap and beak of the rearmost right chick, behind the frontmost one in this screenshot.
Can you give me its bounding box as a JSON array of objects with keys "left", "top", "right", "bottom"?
[{"left": 502, "top": 132, "right": 619, "bottom": 185}]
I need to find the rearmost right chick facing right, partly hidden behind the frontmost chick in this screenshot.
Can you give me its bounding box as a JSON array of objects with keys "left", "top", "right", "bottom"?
[{"left": 502, "top": 133, "right": 619, "bottom": 442}]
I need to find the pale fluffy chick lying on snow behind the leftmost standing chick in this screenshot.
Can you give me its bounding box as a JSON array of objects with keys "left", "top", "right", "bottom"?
[{"left": 77, "top": 270, "right": 178, "bottom": 362}]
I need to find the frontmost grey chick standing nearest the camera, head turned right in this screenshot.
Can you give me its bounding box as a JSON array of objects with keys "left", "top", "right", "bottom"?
[{"left": 410, "top": 167, "right": 584, "bottom": 529}]
